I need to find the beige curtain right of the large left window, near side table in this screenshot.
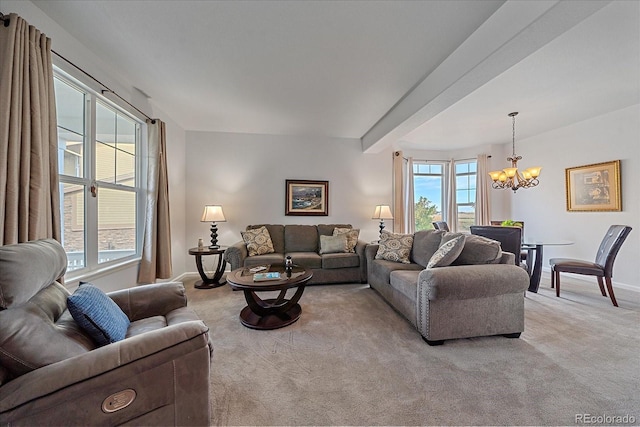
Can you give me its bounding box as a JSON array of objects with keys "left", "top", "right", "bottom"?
[{"left": 138, "top": 119, "right": 172, "bottom": 283}]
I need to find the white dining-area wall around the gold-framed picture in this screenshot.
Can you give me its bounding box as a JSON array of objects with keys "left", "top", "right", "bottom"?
[{"left": 495, "top": 105, "right": 640, "bottom": 289}]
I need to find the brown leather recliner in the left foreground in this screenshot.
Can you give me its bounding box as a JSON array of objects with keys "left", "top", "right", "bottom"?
[{"left": 0, "top": 239, "right": 212, "bottom": 426}]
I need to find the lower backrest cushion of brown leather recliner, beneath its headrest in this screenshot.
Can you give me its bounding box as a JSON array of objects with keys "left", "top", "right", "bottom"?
[{"left": 0, "top": 282, "right": 96, "bottom": 377}]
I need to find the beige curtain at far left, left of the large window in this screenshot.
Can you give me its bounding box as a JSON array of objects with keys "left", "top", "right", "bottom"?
[{"left": 0, "top": 13, "right": 61, "bottom": 245}]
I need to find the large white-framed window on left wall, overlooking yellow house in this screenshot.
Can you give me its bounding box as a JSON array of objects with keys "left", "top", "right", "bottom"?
[{"left": 54, "top": 72, "right": 144, "bottom": 275}]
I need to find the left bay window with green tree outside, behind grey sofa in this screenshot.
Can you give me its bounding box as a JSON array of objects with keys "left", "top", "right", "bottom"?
[{"left": 413, "top": 161, "right": 446, "bottom": 231}]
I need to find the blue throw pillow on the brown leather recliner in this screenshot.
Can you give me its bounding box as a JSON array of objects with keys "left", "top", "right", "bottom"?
[{"left": 67, "top": 284, "right": 130, "bottom": 346}]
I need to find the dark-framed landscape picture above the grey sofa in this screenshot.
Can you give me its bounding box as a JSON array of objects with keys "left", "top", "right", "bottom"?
[{"left": 285, "top": 179, "right": 329, "bottom": 216}]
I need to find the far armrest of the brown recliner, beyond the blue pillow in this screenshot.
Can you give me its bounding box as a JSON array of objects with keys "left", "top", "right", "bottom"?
[{"left": 107, "top": 282, "right": 187, "bottom": 322}]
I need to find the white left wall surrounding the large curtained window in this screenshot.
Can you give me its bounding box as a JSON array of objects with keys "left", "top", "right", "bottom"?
[{"left": 0, "top": 0, "right": 187, "bottom": 290}]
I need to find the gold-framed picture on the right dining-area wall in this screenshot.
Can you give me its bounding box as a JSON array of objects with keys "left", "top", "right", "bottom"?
[{"left": 565, "top": 160, "right": 622, "bottom": 212}]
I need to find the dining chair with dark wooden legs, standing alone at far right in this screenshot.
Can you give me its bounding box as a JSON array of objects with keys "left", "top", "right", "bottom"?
[{"left": 549, "top": 225, "right": 631, "bottom": 307}]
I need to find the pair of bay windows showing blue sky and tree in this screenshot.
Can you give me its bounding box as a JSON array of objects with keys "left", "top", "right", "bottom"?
[{"left": 413, "top": 160, "right": 477, "bottom": 232}]
